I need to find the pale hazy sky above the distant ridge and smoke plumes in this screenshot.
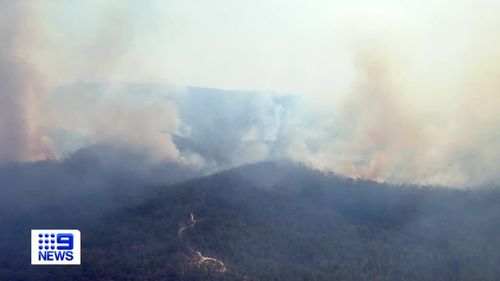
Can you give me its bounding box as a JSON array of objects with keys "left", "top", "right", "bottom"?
[{"left": 36, "top": 0, "right": 500, "bottom": 92}]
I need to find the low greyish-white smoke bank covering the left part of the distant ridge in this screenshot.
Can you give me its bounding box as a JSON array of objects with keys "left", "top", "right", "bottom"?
[{"left": 43, "top": 86, "right": 183, "bottom": 161}]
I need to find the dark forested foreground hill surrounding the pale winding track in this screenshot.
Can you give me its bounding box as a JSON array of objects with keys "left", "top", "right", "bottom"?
[{"left": 0, "top": 163, "right": 500, "bottom": 281}]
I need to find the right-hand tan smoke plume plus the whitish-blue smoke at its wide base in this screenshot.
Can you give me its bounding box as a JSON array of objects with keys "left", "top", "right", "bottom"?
[{"left": 289, "top": 45, "right": 435, "bottom": 183}]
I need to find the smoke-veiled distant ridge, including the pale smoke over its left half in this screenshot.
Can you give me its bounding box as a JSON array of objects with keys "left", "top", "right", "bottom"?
[{"left": 45, "top": 83, "right": 296, "bottom": 171}]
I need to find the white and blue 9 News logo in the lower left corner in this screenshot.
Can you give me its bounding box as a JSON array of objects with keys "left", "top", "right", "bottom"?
[{"left": 31, "top": 229, "right": 81, "bottom": 265}]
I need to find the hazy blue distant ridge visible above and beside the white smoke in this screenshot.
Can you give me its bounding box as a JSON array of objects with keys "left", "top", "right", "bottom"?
[{"left": 50, "top": 83, "right": 298, "bottom": 167}]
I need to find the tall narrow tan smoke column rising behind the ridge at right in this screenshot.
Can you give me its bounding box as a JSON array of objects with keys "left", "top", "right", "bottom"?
[{"left": 332, "top": 46, "right": 429, "bottom": 180}]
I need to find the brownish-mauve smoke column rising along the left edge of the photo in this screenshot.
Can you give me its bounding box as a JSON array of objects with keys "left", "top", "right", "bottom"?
[{"left": 0, "top": 1, "right": 54, "bottom": 163}]
